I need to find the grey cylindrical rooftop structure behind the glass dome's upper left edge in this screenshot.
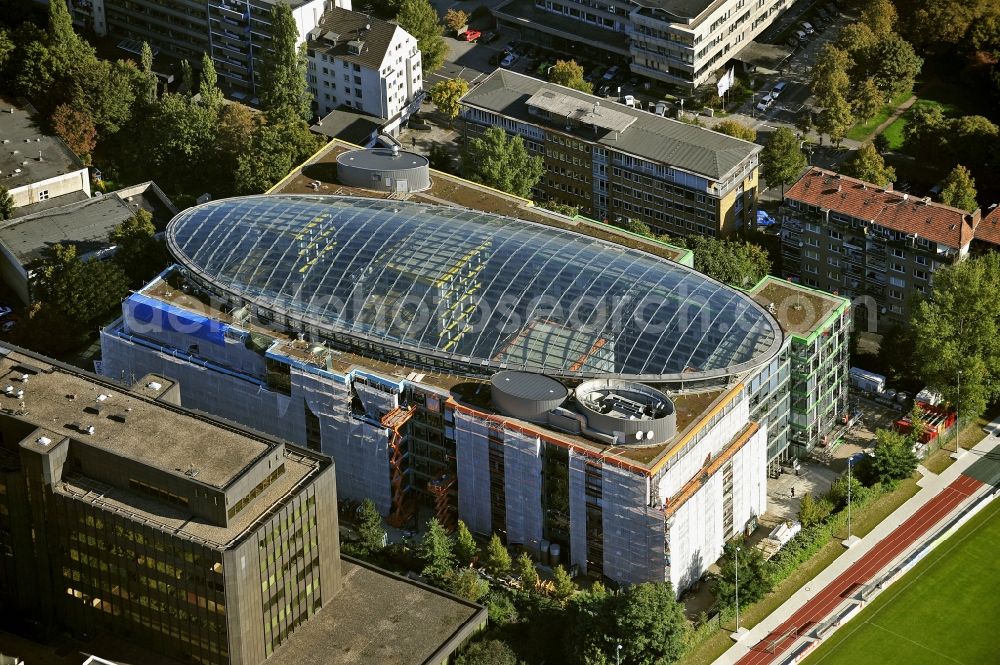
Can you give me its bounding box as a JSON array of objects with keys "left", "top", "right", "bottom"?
[{"left": 337, "top": 146, "right": 431, "bottom": 192}]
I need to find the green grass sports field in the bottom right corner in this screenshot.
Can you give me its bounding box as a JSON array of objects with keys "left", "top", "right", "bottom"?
[{"left": 805, "top": 492, "right": 1000, "bottom": 665}]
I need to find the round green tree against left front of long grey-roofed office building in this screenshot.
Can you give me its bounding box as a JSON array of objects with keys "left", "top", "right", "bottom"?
[{"left": 464, "top": 127, "right": 545, "bottom": 198}]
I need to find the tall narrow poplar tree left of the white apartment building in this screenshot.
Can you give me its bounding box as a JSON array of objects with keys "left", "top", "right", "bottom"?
[{"left": 259, "top": 2, "right": 312, "bottom": 124}]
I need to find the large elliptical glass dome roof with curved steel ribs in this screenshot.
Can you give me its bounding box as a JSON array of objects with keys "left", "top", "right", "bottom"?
[{"left": 167, "top": 195, "right": 782, "bottom": 381}]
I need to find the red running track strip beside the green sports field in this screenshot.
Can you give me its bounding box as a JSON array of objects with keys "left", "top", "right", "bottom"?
[{"left": 738, "top": 475, "right": 982, "bottom": 665}]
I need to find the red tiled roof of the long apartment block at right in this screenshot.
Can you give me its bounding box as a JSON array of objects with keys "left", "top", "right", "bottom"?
[{"left": 785, "top": 168, "right": 980, "bottom": 249}]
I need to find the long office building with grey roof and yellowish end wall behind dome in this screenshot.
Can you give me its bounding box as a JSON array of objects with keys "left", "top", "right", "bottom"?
[{"left": 461, "top": 69, "right": 762, "bottom": 237}]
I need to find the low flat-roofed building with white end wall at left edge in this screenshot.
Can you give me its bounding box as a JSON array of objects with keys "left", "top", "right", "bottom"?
[{"left": 0, "top": 99, "right": 90, "bottom": 216}]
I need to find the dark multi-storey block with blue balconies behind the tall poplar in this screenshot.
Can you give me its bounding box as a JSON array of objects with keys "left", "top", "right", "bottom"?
[{"left": 70, "top": 0, "right": 351, "bottom": 100}]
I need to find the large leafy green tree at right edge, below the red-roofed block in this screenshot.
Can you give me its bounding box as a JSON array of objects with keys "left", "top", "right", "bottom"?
[{"left": 911, "top": 252, "right": 1000, "bottom": 417}]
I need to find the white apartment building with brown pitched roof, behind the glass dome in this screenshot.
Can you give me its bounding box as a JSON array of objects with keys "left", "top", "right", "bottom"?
[{"left": 307, "top": 8, "right": 423, "bottom": 135}]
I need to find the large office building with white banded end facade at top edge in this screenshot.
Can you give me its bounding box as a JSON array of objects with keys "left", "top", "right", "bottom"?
[{"left": 493, "top": 0, "right": 791, "bottom": 89}]
